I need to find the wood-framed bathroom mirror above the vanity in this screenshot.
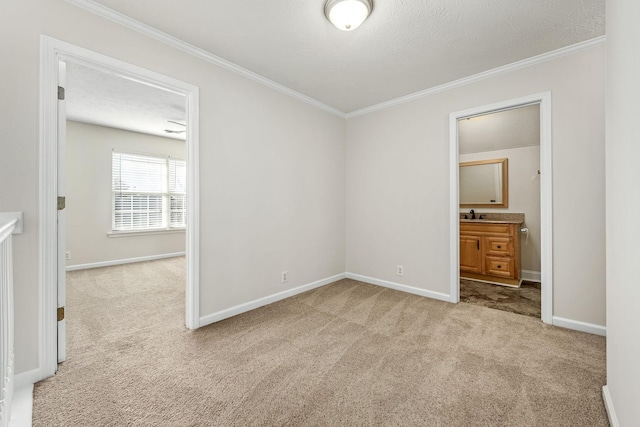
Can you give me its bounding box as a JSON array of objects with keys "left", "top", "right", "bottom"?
[{"left": 460, "top": 159, "right": 509, "bottom": 208}]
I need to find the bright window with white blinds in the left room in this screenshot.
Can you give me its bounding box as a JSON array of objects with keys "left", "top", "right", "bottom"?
[{"left": 111, "top": 151, "right": 187, "bottom": 231}]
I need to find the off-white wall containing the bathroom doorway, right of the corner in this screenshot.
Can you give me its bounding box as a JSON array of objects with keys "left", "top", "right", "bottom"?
[{"left": 347, "top": 46, "right": 605, "bottom": 325}]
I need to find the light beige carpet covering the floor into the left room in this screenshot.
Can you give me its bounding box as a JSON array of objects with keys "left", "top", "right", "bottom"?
[{"left": 33, "top": 259, "right": 607, "bottom": 426}]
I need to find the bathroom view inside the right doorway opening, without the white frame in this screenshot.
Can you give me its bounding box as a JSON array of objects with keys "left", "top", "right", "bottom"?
[{"left": 458, "top": 103, "right": 541, "bottom": 318}]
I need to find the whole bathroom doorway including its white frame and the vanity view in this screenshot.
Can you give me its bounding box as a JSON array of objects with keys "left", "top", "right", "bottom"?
[{"left": 451, "top": 93, "right": 552, "bottom": 323}]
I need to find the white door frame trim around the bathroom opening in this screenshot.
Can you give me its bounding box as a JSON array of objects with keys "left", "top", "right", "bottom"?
[{"left": 449, "top": 92, "right": 553, "bottom": 324}]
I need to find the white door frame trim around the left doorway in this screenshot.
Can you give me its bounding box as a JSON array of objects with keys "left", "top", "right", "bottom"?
[{"left": 39, "top": 36, "right": 200, "bottom": 379}]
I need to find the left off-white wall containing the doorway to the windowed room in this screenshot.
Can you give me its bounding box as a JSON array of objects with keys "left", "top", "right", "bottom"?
[{"left": 0, "top": 0, "right": 345, "bottom": 373}]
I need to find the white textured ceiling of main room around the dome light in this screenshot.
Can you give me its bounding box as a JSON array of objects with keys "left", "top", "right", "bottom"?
[{"left": 89, "top": 0, "right": 605, "bottom": 113}]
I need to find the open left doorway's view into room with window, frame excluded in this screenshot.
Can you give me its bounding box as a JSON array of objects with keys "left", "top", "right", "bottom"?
[{"left": 58, "top": 60, "right": 187, "bottom": 362}]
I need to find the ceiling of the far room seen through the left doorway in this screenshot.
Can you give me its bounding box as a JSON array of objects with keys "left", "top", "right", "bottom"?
[{"left": 66, "top": 62, "right": 186, "bottom": 139}]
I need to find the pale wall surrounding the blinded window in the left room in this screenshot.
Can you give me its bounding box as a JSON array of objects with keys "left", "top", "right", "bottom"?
[{"left": 66, "top": 121, "right": 187, "bottom": 266}]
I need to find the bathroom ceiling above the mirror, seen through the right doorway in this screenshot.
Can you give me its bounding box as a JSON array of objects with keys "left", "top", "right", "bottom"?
[{"left": 458, "top": 104, "right": 540, "bottom": 154}]
